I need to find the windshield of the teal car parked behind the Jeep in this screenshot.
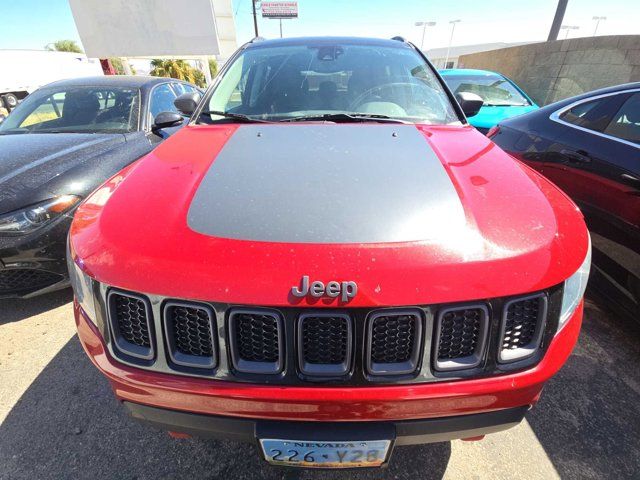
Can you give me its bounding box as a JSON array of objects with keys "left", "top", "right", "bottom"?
[{"left": 442, "top": 75, "right": 531, "bottom": 107}]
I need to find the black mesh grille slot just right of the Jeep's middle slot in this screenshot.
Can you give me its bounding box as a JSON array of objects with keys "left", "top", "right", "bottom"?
[{"left": 371, "top": 315, "right": 417, "bottom": 363}]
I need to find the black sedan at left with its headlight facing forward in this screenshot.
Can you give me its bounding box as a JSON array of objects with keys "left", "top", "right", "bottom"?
[{"left": 0, "top": 76, "right": 197, "bottom": 298}]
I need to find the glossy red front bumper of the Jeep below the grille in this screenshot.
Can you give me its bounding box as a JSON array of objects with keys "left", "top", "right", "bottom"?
[{"left": 74, "top": 304, "right": 583, "bottom": 422}]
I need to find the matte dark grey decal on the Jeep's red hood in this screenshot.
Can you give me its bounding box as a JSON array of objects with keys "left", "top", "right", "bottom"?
[{"left": 187, "top": 124, "right": 465, "bottom": 243}]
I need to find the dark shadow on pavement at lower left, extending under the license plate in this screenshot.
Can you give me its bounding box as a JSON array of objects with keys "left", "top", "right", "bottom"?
[{"left": 0, "top": 337, "right": 451, "bottom": 480}]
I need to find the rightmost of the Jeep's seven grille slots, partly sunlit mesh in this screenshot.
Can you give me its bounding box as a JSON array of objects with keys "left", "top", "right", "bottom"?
[{"left": 499, "top": 294, "right": 547, "bottom": 362}]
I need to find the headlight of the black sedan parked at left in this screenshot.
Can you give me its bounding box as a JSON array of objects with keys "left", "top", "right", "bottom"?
[{"left": 0, "top": 195, "right": 80, "bottom": 234}]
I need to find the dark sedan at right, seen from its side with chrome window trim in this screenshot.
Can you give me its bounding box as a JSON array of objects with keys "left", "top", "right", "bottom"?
[{"left": 489, "top": 83, "right": 640, "bottom": 319}]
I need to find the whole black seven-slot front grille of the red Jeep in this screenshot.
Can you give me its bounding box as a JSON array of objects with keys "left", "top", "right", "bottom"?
[{"left": 97, "top": 286, "right": 562, "bottom": 385}]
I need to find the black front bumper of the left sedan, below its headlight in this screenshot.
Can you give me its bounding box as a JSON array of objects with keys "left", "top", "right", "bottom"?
[{"left": 0, "top": 214, "right": 71, "bottom": 298}]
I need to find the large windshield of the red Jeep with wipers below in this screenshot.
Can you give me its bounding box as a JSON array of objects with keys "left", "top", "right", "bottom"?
[{"left": 200, "top": 43, "right": 459, "bottom": 124}]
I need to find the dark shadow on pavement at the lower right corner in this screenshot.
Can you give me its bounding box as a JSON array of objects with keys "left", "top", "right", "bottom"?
[{"left": 527, "top": 301, "right": 640, "bottom": 479}]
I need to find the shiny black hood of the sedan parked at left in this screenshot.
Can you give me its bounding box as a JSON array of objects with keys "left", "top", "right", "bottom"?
[{"left": 0, "top": 133, "right": 127, "bottom": 213}]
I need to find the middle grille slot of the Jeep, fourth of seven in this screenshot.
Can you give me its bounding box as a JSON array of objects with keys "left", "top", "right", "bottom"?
[{"left": 298, "top": 313, "right": 352, "bottom": 375}]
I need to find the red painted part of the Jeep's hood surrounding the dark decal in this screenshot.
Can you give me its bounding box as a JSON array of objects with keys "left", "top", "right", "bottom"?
[{"left": 70, "top": 125, "right": 588, "bottom": 306}]
